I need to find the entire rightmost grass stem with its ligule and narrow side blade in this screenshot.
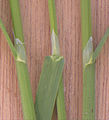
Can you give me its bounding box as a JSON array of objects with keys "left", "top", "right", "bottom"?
[{"left": 81, "top": 0, "right": 109, "bottom": 120}]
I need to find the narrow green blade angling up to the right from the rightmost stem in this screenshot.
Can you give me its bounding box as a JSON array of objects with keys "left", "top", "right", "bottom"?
[{"left": 93, "top": 28, "right": 109, "bottom": 61}]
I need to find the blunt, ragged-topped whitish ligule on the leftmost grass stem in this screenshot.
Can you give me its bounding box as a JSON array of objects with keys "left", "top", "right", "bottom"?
[{"left": 15, "top": 38, "right": 26, "bottom": 63}]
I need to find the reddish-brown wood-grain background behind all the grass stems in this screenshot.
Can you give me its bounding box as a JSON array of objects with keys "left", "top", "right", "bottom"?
[{"left": 0, "top": 0, "right": 109, "bottom": 120}]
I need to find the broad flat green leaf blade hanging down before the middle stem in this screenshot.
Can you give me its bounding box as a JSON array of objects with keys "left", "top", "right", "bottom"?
[{"left": 35, "top": 56, "right": 64, "bottom": 120}]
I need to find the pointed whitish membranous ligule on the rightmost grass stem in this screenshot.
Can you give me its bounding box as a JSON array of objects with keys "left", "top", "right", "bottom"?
[{"left": 83, "top": 36, "right": 93, "bottom": 68}]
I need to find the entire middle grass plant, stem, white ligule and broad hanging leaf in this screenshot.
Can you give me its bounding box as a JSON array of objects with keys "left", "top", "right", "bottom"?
[{"left": 35, "top": 0, "right": 66, "bottom": 120}]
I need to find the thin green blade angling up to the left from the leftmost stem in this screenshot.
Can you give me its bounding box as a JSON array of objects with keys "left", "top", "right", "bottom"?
[{"left": 0, "top": 20, "right": 17, "bottom": 59}]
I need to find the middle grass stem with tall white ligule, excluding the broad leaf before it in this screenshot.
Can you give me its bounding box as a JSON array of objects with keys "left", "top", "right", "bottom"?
[{"left": 48, "top": 0, "right": 66, "bottom": 120}]
